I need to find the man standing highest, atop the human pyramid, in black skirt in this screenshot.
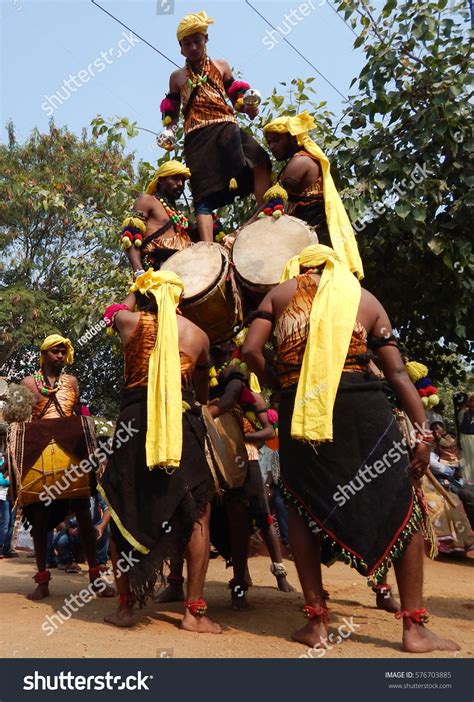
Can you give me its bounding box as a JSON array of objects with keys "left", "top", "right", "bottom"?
[{"left": 161, "top": 12, "right": 271, "bottom": 241}]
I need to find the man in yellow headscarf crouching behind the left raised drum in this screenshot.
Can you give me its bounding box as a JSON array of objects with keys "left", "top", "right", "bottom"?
[{"left": 120, "top": 160, "right": 192, "bottom": 278}]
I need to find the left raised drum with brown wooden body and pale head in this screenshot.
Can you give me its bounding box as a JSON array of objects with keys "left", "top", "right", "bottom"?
[{"left": 161, "top": 241, "right": 243, "bottom": 344}]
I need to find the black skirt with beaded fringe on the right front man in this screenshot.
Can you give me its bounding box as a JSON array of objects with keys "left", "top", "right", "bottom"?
[{"left": 279, "top": 373, "right": 423, "bottom": 581}]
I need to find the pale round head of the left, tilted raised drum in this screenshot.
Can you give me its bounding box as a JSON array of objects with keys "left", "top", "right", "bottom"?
[{"left": 161, "top": 241, "right": 224, "bottom": 300}]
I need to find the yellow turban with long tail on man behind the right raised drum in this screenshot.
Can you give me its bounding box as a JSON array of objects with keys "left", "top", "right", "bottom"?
[{"left": 263, "top": 110, "right": 364, "bottom": 279}]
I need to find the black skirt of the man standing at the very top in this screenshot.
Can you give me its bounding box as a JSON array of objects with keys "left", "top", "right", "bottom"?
[{"left": 184, "top": 122, "right": 271, "bottom": 209}]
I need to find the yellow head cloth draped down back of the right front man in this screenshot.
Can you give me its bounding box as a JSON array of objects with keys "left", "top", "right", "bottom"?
[{"left": 280, "top": 244, "right": 361, "bottom": 442}]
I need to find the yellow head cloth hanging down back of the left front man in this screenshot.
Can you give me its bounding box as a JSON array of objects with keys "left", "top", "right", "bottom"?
[{"left": 130, "top": 269, "right": 183, "bottom": 470}]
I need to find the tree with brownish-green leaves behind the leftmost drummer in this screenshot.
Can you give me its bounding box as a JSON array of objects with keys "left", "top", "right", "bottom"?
[{"left": 0, "top": 122, "right": 134, "bottom": 414}]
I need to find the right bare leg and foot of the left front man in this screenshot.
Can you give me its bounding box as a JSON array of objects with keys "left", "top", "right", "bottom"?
[{"left": 181, "top": 505, "right": 222, "bottom": 634}]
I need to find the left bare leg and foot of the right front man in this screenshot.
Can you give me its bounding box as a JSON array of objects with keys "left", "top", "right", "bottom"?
[{"left": 288, "top": 505, "right": 328, "bottom": 646}]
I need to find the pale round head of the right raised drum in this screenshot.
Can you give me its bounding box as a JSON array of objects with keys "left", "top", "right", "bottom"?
[{"left": 232, "top": 215, "right": 318, "bottom": 287}]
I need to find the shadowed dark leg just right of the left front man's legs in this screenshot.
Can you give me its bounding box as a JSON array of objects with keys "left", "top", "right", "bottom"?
[{"left": 226, "top": 496, "right": 251, "bottom": 610}]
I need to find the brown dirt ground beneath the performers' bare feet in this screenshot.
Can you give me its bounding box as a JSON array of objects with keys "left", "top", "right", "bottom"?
[{"left": 0, "top": 554, "right": 474, "bottom": 660}]
